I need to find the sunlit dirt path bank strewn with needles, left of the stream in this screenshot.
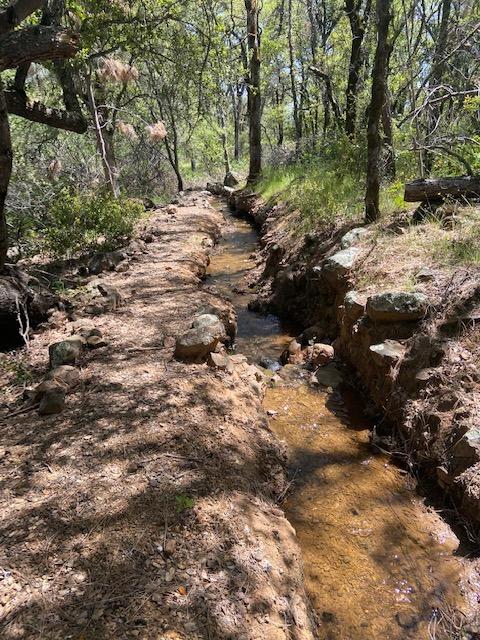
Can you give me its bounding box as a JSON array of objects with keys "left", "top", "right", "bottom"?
[{"left": 0, "top": 194, "right": 313, "bottom": 640}]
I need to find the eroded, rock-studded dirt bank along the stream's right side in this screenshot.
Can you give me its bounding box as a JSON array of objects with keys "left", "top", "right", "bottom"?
[{"left": 231, "top": 192, "right": 480, "bottom": 542}]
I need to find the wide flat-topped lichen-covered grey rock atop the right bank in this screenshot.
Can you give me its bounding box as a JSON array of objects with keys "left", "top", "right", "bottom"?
[{"left": 367, "top": 291, "right": 428, "bottom": 322}]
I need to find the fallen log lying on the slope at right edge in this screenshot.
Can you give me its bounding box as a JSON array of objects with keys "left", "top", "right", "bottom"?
[{"left": 404, "top": 176, "right": 480, "bottom": 202}]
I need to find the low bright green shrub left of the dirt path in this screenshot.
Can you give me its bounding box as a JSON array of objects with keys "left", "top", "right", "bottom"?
[{"left": 42, "top": 189, "right": 144, "bottom": 257}]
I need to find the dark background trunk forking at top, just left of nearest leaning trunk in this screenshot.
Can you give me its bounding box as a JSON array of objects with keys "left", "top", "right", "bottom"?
[{"left": 345, "top": 0, "right": 370, "bottom": 138}]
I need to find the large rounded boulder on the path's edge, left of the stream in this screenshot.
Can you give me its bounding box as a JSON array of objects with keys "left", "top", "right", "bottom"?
[{"left": 175, "top": 313, "right": 226, "bottom": 362}]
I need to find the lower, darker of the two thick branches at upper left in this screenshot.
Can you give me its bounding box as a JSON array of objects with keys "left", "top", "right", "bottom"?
[{"left": 4, "top": 90, "right": 87, "bottom": 133}]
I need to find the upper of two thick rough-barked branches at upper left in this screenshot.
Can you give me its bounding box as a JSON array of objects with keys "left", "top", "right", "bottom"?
[{"left": 0, "top": 26, "right": 78, "bottom": 71}]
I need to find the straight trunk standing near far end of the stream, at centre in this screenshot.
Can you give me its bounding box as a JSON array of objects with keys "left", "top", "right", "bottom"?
[{"left": 245, "top": 0, "right": 262, "bottom": 182}]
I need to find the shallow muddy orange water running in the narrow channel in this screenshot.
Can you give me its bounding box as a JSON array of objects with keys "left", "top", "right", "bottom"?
[{"left": 209, "top": 204, "right": 478, "bottom": 640}]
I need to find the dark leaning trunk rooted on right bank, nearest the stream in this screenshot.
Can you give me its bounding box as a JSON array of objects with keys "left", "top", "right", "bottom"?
[{"left": 365, "top": 0, "right": 392, "bottom": 222}]
